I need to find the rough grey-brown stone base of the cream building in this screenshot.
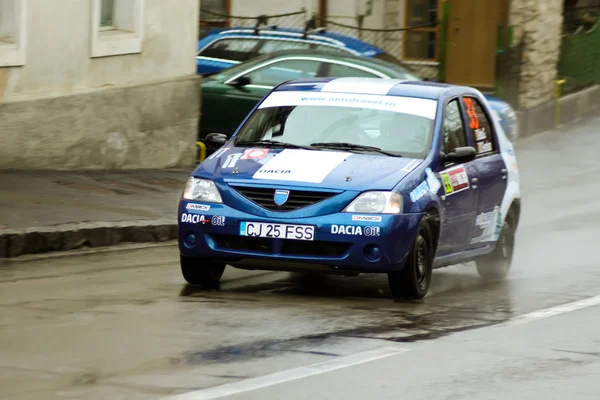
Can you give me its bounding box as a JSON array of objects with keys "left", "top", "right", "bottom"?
[{"left": 0, "top": 76, "right": 200, "bottom": 170}]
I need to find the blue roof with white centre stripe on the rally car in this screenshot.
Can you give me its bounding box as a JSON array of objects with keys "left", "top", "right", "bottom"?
[{"left": 275, "top": 78, "right": 462, "bottom": 100}]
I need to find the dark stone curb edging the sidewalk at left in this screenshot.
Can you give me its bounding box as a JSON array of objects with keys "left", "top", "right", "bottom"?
[{"left": 0, "top": 220, "right": 178, "bottom": 258}]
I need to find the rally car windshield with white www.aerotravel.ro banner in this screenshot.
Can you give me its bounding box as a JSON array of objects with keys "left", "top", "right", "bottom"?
[{"left": 236, "top": 91, "right": 437, "bottom": 158}]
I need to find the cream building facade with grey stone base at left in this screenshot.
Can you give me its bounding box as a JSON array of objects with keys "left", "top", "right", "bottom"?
[{"left": 0, "top": 0, "right": 200, "bottom": 169}]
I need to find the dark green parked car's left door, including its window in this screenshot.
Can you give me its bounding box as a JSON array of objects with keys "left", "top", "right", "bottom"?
[{"left": 222, "top": 58, "right": 321, "bottom": 135}]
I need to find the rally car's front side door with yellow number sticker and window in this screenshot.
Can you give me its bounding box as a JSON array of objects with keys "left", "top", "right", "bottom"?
[{"left": 435, "top": 98, "right": 479, "bottom": 256}]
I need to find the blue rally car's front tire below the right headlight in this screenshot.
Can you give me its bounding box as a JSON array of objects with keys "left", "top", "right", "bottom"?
[{"left": 388, "top": 219, "right": 434, "bottom": 299}]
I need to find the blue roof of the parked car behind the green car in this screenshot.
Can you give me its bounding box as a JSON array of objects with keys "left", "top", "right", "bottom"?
[{"left": 201, "top": 27, "right": 383, "bottom": 55}]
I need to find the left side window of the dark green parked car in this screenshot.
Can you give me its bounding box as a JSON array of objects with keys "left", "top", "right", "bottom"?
[{"left": 246, "top": 60, "right": 321, "bottom": 86}]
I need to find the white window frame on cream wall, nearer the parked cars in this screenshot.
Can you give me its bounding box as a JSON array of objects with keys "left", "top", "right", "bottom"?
[{"left": 91, "top": 0, "right": 145, "bottom": 58}]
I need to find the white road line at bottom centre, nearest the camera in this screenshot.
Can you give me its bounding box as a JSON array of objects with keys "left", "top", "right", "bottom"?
[{"left": 168, "top": 347, "right": 408, "bottom": 400}]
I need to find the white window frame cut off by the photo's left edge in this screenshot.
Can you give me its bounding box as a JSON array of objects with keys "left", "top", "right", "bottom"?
[{"left": 0, "top": 0, "right": 28, "bottom": 67}]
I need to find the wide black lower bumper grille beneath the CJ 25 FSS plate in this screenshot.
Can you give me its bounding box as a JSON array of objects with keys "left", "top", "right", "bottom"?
[{"left": 211, "top": 235, "right": 352, "bottom": 258}]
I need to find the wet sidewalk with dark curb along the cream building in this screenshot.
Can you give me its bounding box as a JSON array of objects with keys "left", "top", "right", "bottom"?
[{"left": 0, "top": 170, "right": 191, "bottom": 258}]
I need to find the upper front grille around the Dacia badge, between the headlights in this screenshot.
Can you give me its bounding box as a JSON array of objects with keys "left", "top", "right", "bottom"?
[{"left": 231, "top": 186, "right": 338, "bottom": 211}]
